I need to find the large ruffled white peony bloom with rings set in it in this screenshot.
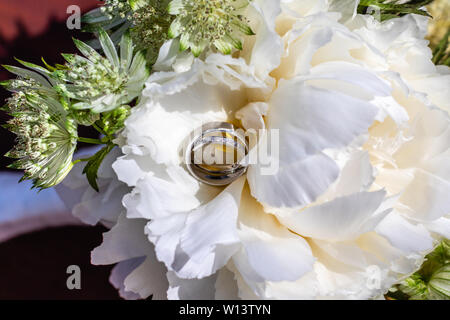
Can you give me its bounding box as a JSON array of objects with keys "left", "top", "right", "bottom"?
[{"left": 78, "top": 0, "right": 450, "bottom": 299}]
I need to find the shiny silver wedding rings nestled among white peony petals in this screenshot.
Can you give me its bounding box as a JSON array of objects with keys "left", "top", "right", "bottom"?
[{"left": 185, "top": 122, "right": 248, "bottom": 186}]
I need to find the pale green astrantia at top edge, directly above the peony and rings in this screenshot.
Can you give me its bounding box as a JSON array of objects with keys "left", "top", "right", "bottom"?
[{"left": 169, "top": 0, "right": 253, "bottom": 56}]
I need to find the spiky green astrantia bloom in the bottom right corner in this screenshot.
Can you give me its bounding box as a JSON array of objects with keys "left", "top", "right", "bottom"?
[{"left": 388, "top": 240, "right": 450, "bottom": 300}]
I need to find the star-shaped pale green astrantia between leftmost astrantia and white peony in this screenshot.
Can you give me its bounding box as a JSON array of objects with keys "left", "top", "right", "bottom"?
[{"left": 57, "top": 30, "right": 149, "bottom": 113}]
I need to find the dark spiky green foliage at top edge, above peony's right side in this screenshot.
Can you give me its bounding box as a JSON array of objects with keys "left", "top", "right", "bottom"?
[{"left": 358, "top": 0, "right": 433, "bottom": 21}]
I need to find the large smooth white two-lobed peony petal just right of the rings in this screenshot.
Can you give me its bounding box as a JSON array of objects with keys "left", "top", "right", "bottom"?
[{"left": 248, "top": 79, "right": 377, "bottom": 208}]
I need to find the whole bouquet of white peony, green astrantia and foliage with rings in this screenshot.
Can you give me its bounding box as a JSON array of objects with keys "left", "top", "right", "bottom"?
[{"left": 3, "top": 0, "right": 450, "bottom": 299}]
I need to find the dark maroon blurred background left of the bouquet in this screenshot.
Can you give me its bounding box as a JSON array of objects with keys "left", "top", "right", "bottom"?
[{"left": 0, "top": 0, "right": 119, "bottom": 299}]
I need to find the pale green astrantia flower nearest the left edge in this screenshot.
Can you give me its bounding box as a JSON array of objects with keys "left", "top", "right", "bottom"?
[{"left": 4, "top": 88, "right": 77, "bottom": 189}]
